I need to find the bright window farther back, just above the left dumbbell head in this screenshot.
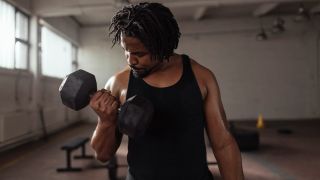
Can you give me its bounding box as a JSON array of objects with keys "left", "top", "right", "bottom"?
[{"left": 41, "top": 26, "right": 76, "bottom": 78}]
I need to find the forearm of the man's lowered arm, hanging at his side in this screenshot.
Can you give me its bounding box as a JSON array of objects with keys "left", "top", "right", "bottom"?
[{"left": 215, "top": 138, "right": 244, "bottom": 180}]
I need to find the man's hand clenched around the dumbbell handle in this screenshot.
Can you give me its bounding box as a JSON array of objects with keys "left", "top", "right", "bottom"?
[{"left": 89, "top": 89, "right": 120, "bottom": 124}]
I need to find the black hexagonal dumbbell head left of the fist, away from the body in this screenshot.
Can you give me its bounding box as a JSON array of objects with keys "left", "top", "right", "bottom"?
[{"left": 59, "top": 69, "right": 97, "bottom": 111}]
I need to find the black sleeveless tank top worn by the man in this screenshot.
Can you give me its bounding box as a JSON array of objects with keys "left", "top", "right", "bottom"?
[{"left": 127, "top": 55, "right": 212, "bottom": 180}]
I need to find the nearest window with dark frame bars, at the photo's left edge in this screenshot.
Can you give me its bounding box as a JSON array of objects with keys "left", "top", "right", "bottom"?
[{"left": 0, "top": 0, "right": 29, "bottom": 69}]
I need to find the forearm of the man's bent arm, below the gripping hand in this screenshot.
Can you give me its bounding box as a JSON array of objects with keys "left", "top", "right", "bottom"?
[{"left": 91, "top": 120, "right": 121, "bottom": 162}]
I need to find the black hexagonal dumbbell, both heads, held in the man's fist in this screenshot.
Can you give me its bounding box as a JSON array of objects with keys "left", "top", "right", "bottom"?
[{"left": 59, "top": 69, "right": 154, "bottom": 138}]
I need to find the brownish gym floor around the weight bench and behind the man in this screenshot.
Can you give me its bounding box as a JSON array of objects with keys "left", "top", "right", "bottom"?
[{"left": 0, "top": 120, "right": 320, "bottom": 180}]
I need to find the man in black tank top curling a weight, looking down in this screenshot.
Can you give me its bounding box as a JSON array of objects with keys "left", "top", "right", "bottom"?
[{"left": 90, "top": 3, "right": 243, "bottom": 180}]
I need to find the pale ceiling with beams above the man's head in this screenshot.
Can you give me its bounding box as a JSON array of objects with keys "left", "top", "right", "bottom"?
[{"left": 32, "top": 0, "right": 320, "bottom": 27}]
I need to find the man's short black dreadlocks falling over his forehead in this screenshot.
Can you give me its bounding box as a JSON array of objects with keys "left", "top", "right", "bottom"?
[{"left": 109, "top": 2, "right": 181, "bottom": 61}]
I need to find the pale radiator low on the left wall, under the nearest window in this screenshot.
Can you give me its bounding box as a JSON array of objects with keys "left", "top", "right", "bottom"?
[{"left": 0, "top": 112, "right": 32, "bottom": 142}]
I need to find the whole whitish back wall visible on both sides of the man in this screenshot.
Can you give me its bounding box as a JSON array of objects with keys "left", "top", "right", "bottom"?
[{"left": 79, "top": 17, "right": 320, "bottom": 120}]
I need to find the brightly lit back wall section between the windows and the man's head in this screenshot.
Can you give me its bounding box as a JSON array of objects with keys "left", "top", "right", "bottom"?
[{"left": 79, "top": 27, "right": 126, "bottom": 121}]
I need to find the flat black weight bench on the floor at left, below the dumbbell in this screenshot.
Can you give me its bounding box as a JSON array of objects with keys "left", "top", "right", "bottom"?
[{"left": 57, "top": 137, "right": 94, "bottom": 172}]
